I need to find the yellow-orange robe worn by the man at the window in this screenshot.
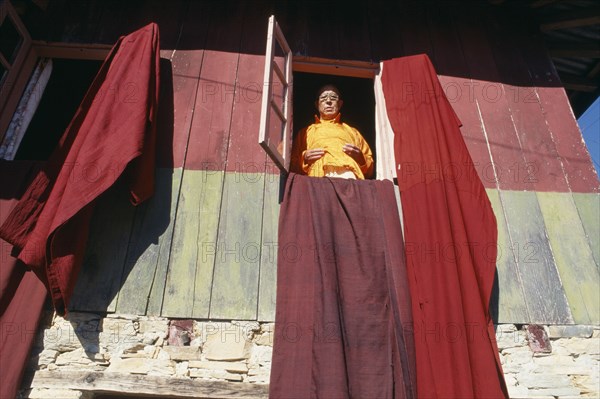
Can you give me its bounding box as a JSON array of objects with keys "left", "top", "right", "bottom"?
[{"left": 291, "top": 114, "right": 373, "bottom": 179}]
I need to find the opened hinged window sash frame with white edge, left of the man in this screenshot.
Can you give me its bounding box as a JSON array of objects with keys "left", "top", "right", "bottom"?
[{"left": 258, "top": 15, "right": 293, "bottom": 173}]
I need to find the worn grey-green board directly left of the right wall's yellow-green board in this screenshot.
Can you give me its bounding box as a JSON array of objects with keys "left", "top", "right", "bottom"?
[{"left": 500, "top": 191, "right": 574, "bottom": 324}]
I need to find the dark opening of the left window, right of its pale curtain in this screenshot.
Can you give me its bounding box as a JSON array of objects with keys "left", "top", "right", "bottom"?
[{"left": 15, "top": 58, "right": 102, "bottom": 161}]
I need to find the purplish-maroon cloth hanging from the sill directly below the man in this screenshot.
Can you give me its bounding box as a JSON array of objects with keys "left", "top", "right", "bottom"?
[{"left": 270, "top": 174, "right": 416, "bottom": 399}]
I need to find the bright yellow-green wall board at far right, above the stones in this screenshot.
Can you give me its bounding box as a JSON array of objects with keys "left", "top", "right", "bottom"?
[{"left": 537, "top": 192, "right": 600, "bottom": 324}]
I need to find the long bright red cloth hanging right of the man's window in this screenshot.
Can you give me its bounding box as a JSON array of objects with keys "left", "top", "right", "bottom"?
[{"left": 382, "top": 55, "right": 508, "bottom": 399}]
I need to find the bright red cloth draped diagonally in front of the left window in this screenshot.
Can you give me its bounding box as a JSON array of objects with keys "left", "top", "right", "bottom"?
[{"left": 0, "top": 24, "right": 159, "bottom": 313}]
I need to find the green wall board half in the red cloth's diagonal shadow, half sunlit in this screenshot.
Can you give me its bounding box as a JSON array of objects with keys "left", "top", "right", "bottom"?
[{"left": 117, "top": 168, "right": 182, "bottom": 315}]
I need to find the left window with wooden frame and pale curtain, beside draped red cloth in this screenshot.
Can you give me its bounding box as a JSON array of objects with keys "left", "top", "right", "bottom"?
[{"left": 0, "top": 1, "right": 110, "bottom": 161}]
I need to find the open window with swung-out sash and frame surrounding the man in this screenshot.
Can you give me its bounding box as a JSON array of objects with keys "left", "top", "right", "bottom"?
[{"left": 259, "top": 16, "right": 396, "bottom": 180}]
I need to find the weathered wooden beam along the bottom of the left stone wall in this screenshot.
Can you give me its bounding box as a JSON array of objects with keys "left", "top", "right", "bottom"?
[{"left": 28, "top": 370, "right": 269, "bottom": 399}]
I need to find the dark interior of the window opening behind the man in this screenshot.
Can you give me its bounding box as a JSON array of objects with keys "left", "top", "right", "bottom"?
[{"left": 293, "top": 72, "right": 377, "bottom": 178}]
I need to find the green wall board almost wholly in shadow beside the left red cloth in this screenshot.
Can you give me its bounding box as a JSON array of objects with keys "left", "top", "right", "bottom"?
[{"left": 69, "top": 184, "right": 135, "bottom": 312}]
